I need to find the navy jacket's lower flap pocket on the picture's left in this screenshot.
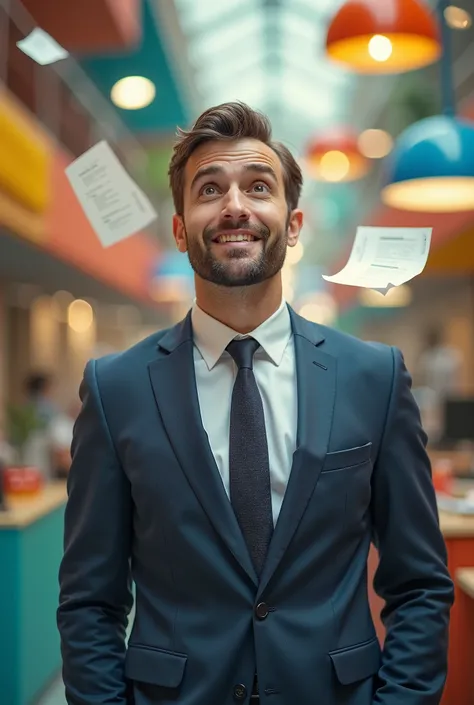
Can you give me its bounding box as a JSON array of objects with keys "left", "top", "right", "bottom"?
[{"left": 125, "top": 644, "right": 188, "bottom": 688}]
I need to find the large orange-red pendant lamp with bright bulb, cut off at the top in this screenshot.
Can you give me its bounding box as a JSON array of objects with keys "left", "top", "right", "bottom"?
[{"left": 326, "top": 0, "right": 442, "bottom": 74}]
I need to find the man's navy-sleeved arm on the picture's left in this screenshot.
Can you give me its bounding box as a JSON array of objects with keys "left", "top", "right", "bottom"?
[{"left": 58, "top": 361, "right": 132, "bottom": 705}]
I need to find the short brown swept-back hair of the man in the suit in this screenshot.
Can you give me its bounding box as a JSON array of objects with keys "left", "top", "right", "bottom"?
[{"left": 168, "top": 102, "right": 303, "bottom": 215}]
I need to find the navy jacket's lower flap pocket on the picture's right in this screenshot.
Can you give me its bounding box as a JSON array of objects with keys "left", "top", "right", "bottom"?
[{"left": 329, "top": 637, "right": 381, "bottom": 685}]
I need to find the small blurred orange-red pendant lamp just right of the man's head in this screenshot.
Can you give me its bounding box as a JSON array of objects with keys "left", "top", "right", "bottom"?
[{"left": 306, "top": 128, "right": 370, "bottom": 183}]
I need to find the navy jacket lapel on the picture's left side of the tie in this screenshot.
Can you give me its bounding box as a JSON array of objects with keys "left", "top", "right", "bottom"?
[{"left": 149, "top": 314, "right": 257, "bottom": 583}]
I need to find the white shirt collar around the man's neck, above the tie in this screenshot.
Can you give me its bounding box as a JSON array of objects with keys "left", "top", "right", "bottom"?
[{"left": 191, "top": 301, "right": 292, "bottom": 370}]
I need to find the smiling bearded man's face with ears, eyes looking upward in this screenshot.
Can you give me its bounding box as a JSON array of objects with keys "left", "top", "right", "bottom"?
[{"left": 173, "top": 139, "right": 302, "bottom": 287}]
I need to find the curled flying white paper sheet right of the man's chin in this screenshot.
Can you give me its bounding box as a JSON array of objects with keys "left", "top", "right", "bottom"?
[{"left": 323, "top": 226, "right": 433, "bottom": 295}]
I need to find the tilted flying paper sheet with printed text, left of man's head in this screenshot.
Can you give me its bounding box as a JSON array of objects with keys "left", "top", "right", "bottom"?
[{"left": 66, "top": 141, "right": 157, "bottom": 247}]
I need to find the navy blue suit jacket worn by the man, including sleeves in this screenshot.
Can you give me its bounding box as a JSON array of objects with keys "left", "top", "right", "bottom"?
[{"left": 58, "top": 309, "right": 453, "bottom": 705}]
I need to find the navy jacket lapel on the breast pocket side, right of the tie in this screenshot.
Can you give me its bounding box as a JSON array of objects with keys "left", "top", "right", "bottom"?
[{"left": 259, "top": 309, "right": 336, "bottom": 594}]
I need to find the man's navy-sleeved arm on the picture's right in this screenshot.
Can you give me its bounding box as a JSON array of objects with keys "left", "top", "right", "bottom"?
[{"left": 372, "top": 348, "right": 454, "bottom": 705}]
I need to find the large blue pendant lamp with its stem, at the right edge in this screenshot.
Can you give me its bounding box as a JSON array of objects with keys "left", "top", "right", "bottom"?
[{"left": 381, "top": 0, "right": 474, "bottom": 213}]
